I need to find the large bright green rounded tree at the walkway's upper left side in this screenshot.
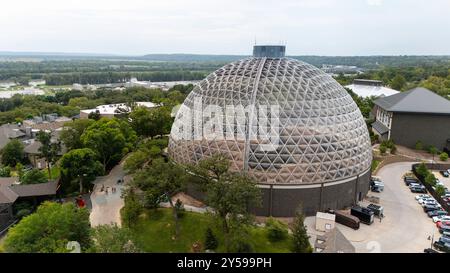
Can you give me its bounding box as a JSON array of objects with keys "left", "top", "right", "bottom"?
[{"left": 81, "top": 118, "right": 136, "bottom": 172}]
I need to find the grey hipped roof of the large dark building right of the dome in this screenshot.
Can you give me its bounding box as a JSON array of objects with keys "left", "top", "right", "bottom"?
[{"left": 375, "top": 87, "right": 450, "bottom": 115}]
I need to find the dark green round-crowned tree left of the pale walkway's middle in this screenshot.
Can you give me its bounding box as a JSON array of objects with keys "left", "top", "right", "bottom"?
[{"left": 59, "top": 148, "right": 102, "bottom": 194}]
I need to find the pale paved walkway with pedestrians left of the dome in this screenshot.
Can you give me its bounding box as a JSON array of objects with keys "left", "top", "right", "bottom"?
[{"left": 89, "top": 161, "right": 128, "bottom": 227}]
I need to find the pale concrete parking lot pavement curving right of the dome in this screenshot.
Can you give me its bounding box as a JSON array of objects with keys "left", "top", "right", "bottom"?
[{"left": 310, "top": 162, "right": 442, "bottom": 253}]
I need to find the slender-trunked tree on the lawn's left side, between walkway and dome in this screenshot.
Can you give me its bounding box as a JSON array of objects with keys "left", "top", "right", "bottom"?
[{"left": 133, "top": 159, "right": 185, "bottom": 238}]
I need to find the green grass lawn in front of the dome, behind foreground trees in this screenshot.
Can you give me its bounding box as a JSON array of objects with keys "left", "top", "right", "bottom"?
[{"left": 132, "top": 208, "right": 290, "bottom": 253}]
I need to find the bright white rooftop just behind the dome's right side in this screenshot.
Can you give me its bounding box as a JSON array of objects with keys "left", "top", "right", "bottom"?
[{"left": 345, "top": 80, "right": 400, "bottom": 98}]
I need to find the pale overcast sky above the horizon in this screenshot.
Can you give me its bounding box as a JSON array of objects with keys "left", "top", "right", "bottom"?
[{"left": 0, "top": 0, "right": 450, "bottom": 55}]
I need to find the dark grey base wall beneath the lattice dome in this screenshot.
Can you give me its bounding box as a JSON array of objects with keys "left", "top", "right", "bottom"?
[{"left": 181, "top": 167, "right": 371, "bottom": 217}]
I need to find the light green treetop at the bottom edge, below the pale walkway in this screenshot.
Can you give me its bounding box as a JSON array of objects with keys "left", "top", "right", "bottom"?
[{"left": 92, "top": 224, "right": 141, "bottom": 253}]
